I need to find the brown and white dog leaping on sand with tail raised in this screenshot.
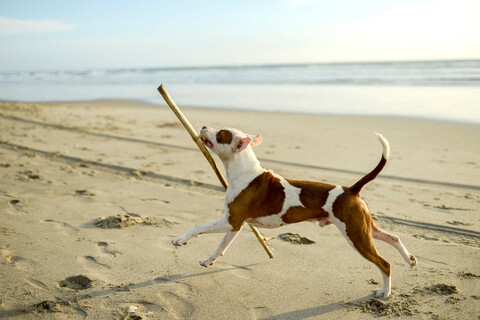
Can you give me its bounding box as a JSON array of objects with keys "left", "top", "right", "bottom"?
[{"left": 172, "top": 127, "right": 417, "bottom": 298}]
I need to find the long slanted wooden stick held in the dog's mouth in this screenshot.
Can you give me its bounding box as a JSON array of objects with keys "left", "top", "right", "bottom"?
[{"left": 157, "top": 85, "right": 273, "bottom": 258}]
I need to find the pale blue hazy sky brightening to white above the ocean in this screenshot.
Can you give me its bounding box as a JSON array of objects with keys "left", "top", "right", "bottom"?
[{"left": 0, "top": 0, "right": 480, "bottom": 71}]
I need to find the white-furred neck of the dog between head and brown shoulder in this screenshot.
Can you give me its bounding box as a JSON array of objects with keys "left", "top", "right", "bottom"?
[{"left": 222, "top": 146, "right": 265, "bottom": 184}]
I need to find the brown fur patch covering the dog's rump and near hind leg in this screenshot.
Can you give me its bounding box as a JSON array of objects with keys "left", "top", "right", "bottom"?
[{"left": 333, "top": 189, "right": 391, "bottom": 277}]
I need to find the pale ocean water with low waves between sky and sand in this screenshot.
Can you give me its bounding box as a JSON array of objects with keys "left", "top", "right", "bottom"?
[{"left": 0, "top": 60, "right": 480, "bottom": 124}]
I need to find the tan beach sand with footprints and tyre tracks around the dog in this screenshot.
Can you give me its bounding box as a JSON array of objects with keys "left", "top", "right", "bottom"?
[{"left": 0, "top": 101, "right": 480, "bottom": 319}]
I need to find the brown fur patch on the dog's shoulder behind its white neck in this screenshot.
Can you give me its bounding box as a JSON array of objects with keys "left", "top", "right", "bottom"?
[{"left": 228, "top": 172, "right": 285, "bottom": 231}]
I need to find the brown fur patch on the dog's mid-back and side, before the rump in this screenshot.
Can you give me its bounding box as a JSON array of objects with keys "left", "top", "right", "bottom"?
[{"left": 282, "top": 179, "right": 335, "bottom": 223}]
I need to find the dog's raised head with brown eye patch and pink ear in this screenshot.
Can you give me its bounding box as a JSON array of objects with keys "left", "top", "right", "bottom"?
[{"left": 200, "top": 127, "right": 263, "bottom": 159}]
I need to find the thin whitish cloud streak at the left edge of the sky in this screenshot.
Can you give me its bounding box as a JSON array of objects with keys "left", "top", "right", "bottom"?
[{"left": 0, "top": 17, "right": 73, "bottom": 36}]
